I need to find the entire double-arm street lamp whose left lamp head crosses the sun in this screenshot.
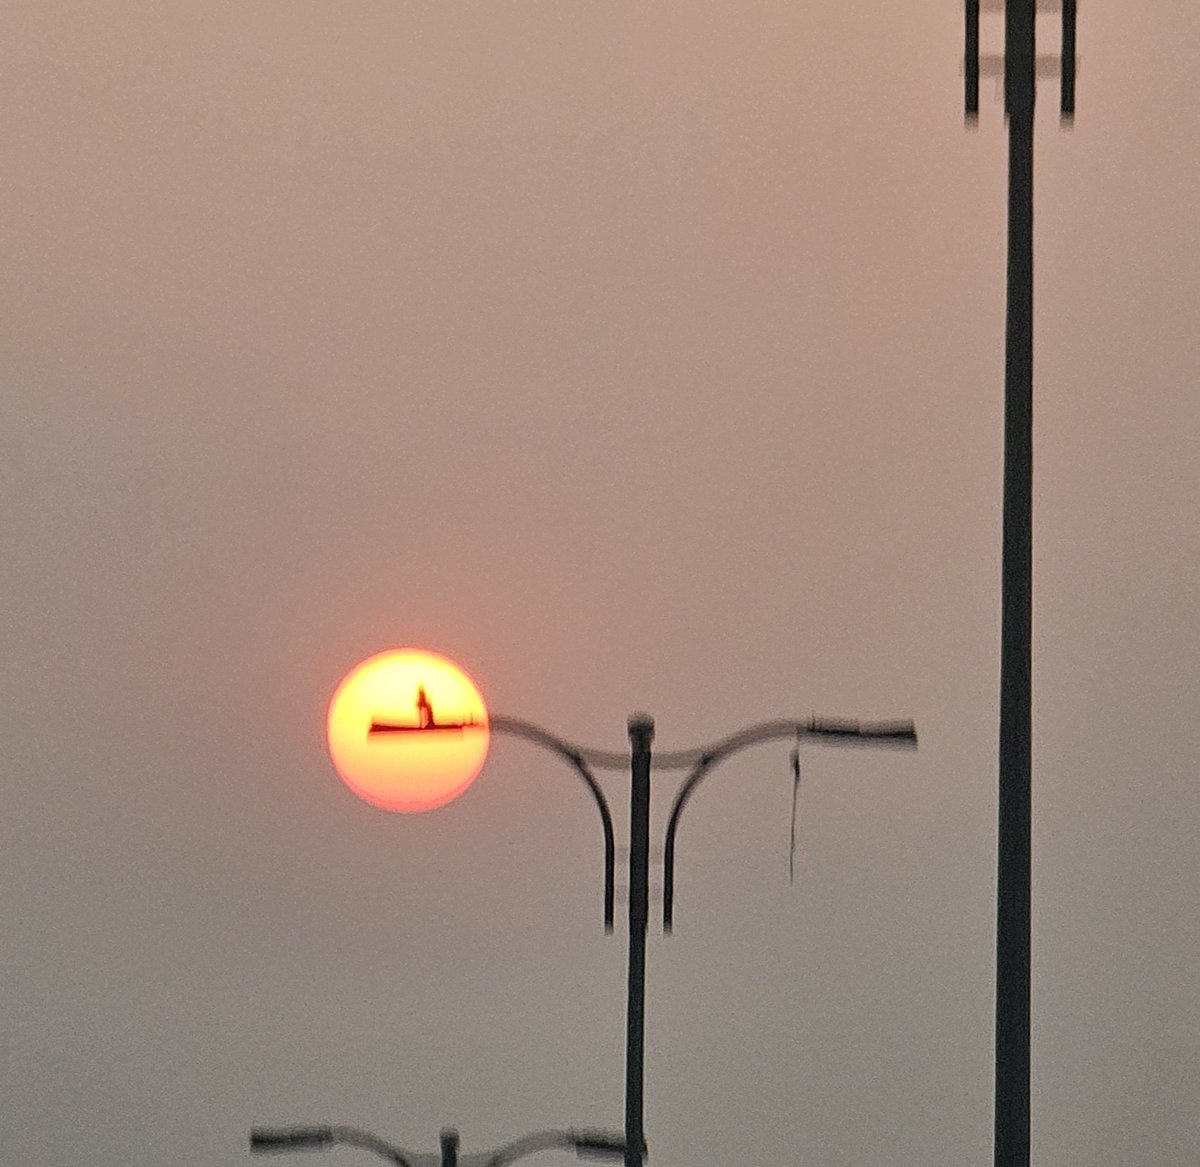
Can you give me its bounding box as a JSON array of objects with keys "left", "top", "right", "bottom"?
[{"left": 370, "top": 713, "right": 917, "bottom": 1167}]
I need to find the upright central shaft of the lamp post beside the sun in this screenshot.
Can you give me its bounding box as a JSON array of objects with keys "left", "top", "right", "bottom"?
[{"left": 625, "top": 713, "right": 654, "bottom": 1167}]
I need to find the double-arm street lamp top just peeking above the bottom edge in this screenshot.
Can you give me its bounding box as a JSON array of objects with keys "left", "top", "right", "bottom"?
[{"left": 250, "top": 1126, "right": 625, "bottom": 1167}]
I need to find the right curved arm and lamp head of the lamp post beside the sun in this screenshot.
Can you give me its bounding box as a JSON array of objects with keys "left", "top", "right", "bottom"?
[{"left": 655, "top": 717, "right": 917, "bottom": 932}]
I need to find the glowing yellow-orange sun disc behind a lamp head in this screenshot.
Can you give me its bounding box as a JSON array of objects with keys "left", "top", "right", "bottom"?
[{"left": 328, "top": 648, "right": 490, "bottom": 813}]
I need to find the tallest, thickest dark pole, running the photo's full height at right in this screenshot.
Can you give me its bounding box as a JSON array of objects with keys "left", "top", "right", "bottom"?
[{"left": 995, "top": 0, "right": 1037, "bottom": 1167}]
